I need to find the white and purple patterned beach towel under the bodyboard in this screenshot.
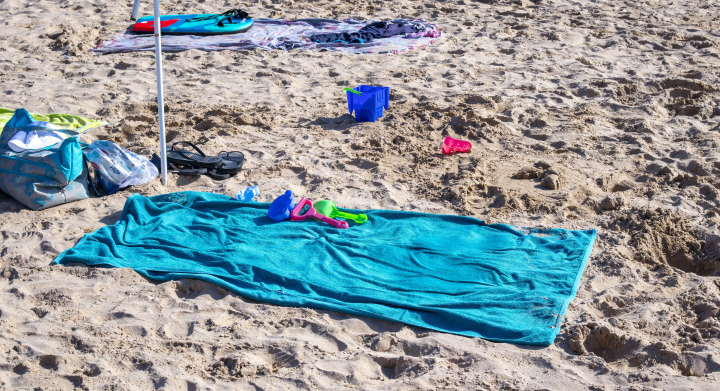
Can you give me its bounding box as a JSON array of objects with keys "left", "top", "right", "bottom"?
[{"left": 92, "top": 18, "right": 442, "bottom": 54}]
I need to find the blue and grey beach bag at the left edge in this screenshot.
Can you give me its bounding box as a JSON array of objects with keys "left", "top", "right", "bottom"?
[{"left": 0, "top": 109, "right": 90, "bottom": 210}]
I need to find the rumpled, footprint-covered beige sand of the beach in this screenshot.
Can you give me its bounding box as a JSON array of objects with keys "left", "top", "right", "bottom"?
[{"left": 0, "top": 0, "right": 720, "bottom": 391}]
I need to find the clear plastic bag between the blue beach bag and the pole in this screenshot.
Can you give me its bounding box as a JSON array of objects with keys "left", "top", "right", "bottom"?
[{"left": 83, "top": 140, "right": 158, "bottom": 190}]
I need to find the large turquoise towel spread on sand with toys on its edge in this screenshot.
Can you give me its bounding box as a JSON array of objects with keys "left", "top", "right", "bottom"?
[{"left": 53, "top": 192, "right": 596, "bottom": 345}]
